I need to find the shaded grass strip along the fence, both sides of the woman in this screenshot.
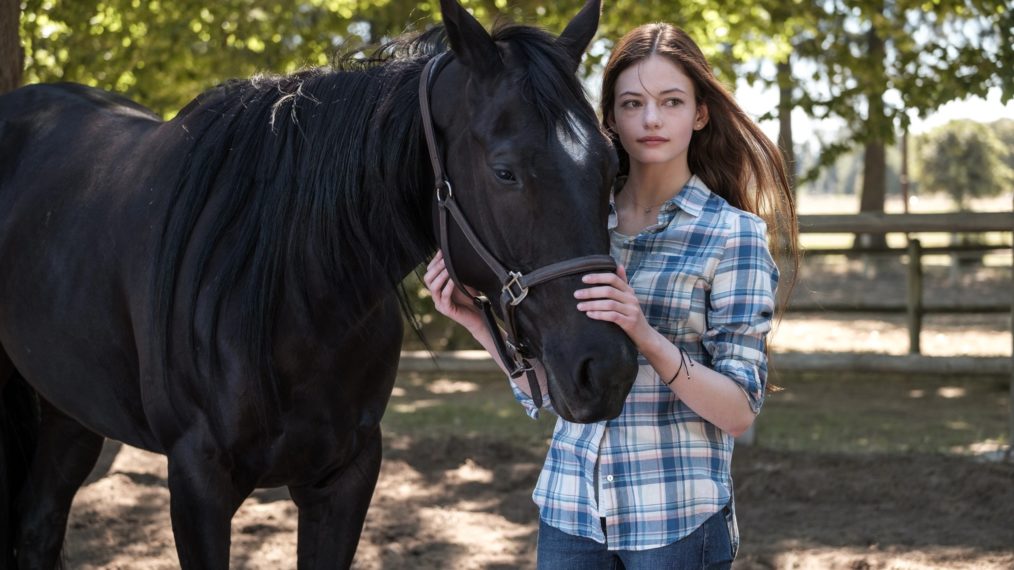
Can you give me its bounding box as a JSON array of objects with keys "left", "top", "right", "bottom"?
[{"left": 383, "top": 373, "right": 1009, "bottom": 454}]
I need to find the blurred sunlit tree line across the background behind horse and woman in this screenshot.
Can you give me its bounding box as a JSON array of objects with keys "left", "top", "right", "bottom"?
[{"left": 0, "top": 0, "right": 1014, "bottom": 346}]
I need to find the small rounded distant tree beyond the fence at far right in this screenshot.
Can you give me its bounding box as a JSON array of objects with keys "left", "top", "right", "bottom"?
[{"left": 919, "top": 121, "right": 1014, "bottom": 210}]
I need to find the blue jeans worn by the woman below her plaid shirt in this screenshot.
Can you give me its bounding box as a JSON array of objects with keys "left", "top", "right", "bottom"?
[{"left": 537, "top": 509, "right": 732, "bottom": 570}]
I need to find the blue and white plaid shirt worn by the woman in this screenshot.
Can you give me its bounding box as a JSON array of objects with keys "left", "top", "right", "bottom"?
[{"left": 511, "top": 176, "right": 778, "bottom": 550}]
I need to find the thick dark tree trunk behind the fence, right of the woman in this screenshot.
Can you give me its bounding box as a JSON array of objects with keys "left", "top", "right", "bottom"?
[{"left": 853, "top": 11, "right": 890, "bottom": 248}]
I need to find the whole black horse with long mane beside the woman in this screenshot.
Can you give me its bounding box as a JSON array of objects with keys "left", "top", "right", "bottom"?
[{"left": 0, "top": 0, "right": 636, "bottom": 568}]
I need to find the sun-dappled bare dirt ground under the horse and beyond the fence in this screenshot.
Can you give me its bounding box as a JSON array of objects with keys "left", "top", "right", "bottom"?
[{"left": 66, "top": 259, "right": 1014, "bottom": 570}]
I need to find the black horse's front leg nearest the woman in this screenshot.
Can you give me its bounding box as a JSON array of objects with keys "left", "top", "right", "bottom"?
[{"left": 289, "top": 426, "right": 381, "bottom": 570}]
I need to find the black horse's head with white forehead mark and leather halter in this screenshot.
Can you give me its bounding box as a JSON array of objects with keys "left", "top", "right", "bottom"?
[{"left": 428, "top": 0, "right": 637, "bottom": 422}]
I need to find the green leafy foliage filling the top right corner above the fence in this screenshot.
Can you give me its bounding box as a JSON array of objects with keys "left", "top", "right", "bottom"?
[{"left": 796, "top": 0, "right": 1014, "bottom": 159}]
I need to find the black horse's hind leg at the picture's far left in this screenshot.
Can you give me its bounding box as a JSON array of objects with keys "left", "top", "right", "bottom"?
[{"left": 17, "top": 399, "right": 104, "bottom": 568}]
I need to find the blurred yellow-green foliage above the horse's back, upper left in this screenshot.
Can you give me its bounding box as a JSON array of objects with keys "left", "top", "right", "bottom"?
[{"left": 21, "top": 0, "right": 431, "bottom": 114}]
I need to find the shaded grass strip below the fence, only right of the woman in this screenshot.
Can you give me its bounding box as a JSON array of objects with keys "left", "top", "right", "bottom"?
[{"left": 757, "top": 373, "right": 1009, "bottom": 453}]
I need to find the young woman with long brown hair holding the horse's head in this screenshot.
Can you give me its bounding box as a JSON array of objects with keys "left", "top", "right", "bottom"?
[{"left": 425, "top": 23, "right": 796, "bottom": 570}]
